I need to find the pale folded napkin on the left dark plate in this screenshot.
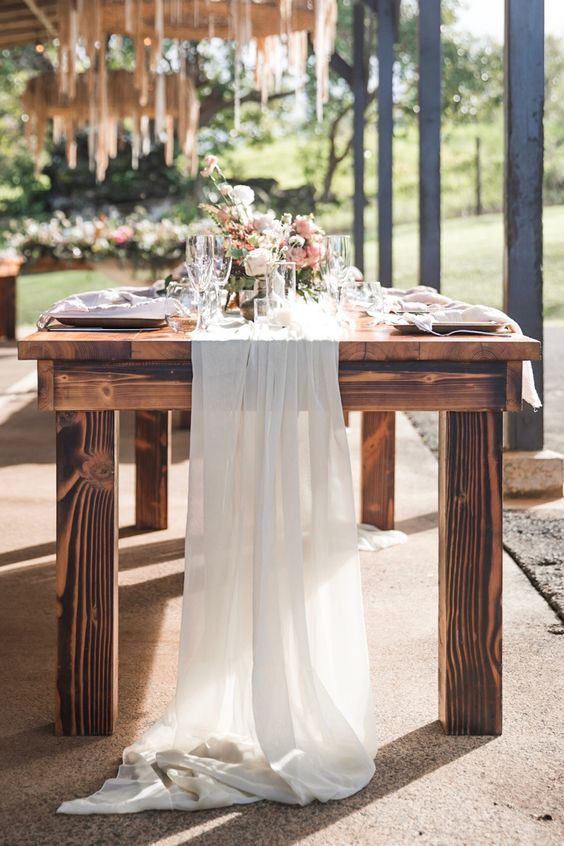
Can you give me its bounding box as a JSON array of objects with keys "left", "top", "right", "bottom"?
[{"left": 37, "top": 283, "right": 165, "bottom": 329}]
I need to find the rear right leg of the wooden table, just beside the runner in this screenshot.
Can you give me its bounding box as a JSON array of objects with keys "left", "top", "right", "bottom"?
[{"left": 361, "top": 411, "right": 396, "bottom": 529}]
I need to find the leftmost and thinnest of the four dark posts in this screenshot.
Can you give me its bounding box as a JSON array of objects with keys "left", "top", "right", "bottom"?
[{"left": 352, "top": 0, "right": 366, "bottom": 271}]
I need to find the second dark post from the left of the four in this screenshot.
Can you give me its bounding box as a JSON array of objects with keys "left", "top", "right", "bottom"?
[{"left": 377, "top": 0, "right": 394, "bottom": 287}]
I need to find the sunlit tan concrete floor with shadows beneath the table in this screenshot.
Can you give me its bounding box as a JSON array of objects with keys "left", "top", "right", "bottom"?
[{"left": 0, "top": 356, "right": 564, "bottom": 846}]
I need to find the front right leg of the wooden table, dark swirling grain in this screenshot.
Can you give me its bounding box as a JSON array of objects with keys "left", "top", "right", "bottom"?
[{"left": 439, "top": 412, "right": 503, "bottom": 735}]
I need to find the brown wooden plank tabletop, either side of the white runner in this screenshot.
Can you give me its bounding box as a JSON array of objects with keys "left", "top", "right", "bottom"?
[{"left": 18, "top": 326, "right": 541, "bottom": 361}]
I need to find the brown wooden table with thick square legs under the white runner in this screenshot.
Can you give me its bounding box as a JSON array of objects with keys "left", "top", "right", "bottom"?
[{"left": 19, "top": 328, "right": 540, "bottom": 735}]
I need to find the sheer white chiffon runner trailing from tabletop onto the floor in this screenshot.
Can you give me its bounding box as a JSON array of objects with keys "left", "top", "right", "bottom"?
[{"left": 59, "top": 312, "right": 376, "bottom": 814}]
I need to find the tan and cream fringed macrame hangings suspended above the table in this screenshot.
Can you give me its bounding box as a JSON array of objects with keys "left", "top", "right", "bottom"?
[{"left": 23, "top": 0, "right": 337, "bottom": 180}]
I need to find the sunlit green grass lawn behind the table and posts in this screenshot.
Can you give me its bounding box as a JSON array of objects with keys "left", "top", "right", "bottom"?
[{"left": 18, "top": 206, "right": 564, "bottom": 325}]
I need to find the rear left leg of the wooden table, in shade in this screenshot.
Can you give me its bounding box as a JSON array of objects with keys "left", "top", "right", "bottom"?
[{"left": 135, "top": 411, "right": 170, "bottom": 529}]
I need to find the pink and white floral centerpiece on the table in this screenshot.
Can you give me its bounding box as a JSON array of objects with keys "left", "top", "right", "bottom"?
[{"left": 201, "top": 156, "right": 325, "bottom": 304}]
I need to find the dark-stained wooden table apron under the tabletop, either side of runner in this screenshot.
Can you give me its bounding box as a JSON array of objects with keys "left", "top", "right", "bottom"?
[{"left": 46, "top": 361, "right": 508, "bottom": 411}]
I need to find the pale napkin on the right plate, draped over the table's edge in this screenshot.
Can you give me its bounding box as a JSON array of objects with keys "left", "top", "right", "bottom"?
[{"left": 388, "top": 289, "right": 542, "bottom": 410}]
